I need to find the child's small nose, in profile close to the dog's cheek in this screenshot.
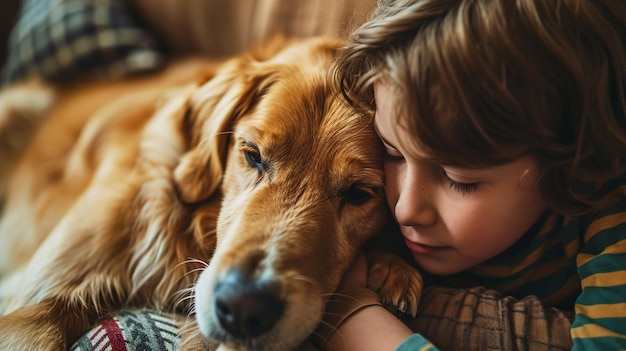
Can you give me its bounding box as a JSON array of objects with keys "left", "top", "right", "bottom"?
[{"left": 394, "top": 169, "right": 437, "bottom": 226}]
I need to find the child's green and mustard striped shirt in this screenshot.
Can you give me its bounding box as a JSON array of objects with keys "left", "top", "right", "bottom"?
[{"left": 398, "top": 178, "right": 626, "bottom": 350}]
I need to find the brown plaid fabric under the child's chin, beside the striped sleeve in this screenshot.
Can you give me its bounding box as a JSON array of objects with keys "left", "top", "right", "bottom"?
[{"left": 405, "top": 287, "right": 573, "bottom": 351}]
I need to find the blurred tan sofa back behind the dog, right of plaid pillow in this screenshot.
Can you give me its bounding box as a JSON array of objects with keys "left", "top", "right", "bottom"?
[{"left": 132, "top": 0, "right": 376, "bottom": 57}]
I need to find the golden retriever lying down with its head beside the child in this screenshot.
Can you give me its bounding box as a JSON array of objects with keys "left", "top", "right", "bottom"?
[{"left": 0, "top": 38, "right": 421, "bottom": 351}]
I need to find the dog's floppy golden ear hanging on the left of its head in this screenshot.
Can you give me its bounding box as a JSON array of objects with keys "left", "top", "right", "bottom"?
[{"left": 174, "top": 57, "right": 270, "bottom": 204}]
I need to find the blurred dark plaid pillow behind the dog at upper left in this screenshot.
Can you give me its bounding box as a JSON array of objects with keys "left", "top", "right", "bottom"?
[{"left": 1, "top": 0, "right": 163, "bottom": 84}]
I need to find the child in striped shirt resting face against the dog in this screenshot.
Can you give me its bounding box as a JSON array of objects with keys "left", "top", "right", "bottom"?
[{"left": 320, "top": 0, "right": 626, "bottom": 351}]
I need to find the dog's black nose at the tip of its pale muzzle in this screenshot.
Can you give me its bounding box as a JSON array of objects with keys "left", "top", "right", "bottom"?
[{"left": 215, "top": 271, "right": 285, "bottom": 338}]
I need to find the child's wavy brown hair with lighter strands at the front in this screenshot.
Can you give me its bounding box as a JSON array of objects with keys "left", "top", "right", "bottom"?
[{"left": 335, "top": 0, "right": 626, "bottom": 215}]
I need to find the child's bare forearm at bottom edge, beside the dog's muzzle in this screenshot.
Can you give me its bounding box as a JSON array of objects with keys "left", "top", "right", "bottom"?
[{"left": 327, "top": 306, "right": 413, "bottom": 351}]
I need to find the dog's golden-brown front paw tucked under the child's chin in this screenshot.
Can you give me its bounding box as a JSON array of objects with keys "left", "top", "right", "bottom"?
[{"left": 367, "top": 251, "right": 424, "bottom": 317}]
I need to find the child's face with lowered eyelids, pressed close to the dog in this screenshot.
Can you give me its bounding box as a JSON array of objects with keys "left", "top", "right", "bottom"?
[{"left": 374, "top": 83, "right": 546, "bottom": 275}]
